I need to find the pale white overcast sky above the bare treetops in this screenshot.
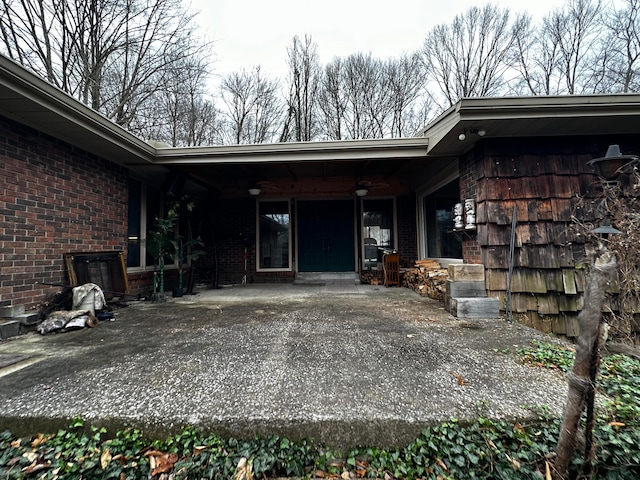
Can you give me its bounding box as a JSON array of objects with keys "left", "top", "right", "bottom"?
[{"left": 191, "top": 0, "right": 620, "bottom": 80}]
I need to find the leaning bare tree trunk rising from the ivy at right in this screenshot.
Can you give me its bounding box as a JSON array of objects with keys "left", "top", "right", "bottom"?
[{"left": 554, "top": 248, "right": 617, "bottom": 479}]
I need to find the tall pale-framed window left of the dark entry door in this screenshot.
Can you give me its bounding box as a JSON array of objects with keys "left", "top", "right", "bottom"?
[{"left": 257, "top": 200, "right": 291, "bottom": 270}]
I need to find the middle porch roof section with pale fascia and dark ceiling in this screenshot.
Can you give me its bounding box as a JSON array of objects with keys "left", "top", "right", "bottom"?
[{"left": 155, "top": 137, "right": 436, "bottom": 197}]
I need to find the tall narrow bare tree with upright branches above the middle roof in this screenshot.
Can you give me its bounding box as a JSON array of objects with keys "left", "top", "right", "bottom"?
[{"left": 281, "top": 35, "right": 321, "bottom": 142}]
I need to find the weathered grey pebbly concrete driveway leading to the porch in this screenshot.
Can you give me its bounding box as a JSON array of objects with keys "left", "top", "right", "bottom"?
[{"left": 0, "top": 282, "right": 566, "bottom": 447}]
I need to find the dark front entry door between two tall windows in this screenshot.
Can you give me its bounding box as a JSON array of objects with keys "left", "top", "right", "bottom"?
[{"left": 296, "top": 200, "right": 355, "bottom": 272}]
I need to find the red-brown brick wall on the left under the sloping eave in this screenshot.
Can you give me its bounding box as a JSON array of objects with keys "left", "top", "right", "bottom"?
[{"left": 0, "top": 117, "right": 128, "bottom": 308}]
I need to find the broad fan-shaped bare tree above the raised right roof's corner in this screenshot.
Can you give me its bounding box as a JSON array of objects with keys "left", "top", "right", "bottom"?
[{"left": 422, "top": 4, "right": 514, "bottom": 109}]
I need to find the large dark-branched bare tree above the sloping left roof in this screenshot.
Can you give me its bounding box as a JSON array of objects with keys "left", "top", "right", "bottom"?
[{"left": 0, "top": 0, "right": 209, "bottom": 127}]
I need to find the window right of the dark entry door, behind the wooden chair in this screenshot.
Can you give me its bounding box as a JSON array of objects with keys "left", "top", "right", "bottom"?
[{"left": 362, "top": 199, "right": 395, "bottom": 268}]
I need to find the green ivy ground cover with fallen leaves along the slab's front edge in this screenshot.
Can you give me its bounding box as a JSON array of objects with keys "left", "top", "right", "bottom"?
[{"left": 0, "top": 342, "right": 640, "bottom": 480}]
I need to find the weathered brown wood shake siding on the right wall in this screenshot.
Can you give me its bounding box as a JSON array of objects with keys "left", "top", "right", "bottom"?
[{"left": 470, "top": 137, "right": 632, "bottom": 337}]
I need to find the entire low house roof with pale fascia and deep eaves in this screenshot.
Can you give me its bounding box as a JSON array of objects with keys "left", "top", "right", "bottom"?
[{"left": 0, "top": 55, "right": 640, "bottom": 195}]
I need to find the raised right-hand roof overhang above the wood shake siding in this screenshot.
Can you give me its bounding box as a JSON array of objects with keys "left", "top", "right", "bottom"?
[{"left": 421, "top": 94, "right": 640, "bottom": 156}]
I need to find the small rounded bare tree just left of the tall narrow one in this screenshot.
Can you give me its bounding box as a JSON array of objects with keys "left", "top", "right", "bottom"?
[{"left": 221, "top": 67, "right": 282, "bottom": 144}]
